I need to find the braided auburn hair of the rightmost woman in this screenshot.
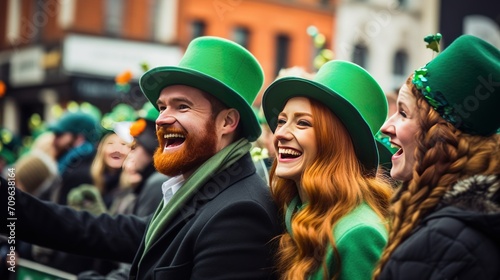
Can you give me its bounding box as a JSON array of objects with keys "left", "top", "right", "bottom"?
[{"left": 373, "top": 75, "right": 500, "bottom": 279}]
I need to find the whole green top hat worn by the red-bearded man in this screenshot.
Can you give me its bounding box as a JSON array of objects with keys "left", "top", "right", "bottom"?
[{"left": 139, "top": 36, "right": 264, "bottom": 141}]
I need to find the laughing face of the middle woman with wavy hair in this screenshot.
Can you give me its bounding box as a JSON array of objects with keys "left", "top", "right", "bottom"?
[{"left": 274, "top": 97, "right": 318, "bottom": 186}]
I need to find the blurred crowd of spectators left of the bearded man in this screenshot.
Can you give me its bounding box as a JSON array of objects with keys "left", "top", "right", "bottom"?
[{"left": 0, "top": 102, "right": 172, "bottom": 279}]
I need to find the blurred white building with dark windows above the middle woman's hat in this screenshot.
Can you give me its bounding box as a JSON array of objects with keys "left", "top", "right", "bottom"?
[{"left": 334, "top": 0, "right": 439, "bottom": 92}]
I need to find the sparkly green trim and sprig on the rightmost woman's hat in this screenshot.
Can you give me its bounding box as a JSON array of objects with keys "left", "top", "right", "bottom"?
[{"left": 412, "top": 33, "right": 461, "bottom": 131}]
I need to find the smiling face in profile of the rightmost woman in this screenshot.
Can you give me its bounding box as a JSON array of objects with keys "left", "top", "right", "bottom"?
[{"left": 381, "top": 84, "right": 420, "bottom": 181}]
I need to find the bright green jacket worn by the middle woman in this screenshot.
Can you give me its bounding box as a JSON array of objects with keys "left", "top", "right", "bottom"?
[{"left": 309, "top": 203, "right": 387, "bottom": 280}]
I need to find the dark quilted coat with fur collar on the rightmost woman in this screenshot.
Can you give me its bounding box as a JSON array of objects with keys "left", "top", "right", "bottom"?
[{"left": 379, "top": 176, "right": 500, "bottom": 280}]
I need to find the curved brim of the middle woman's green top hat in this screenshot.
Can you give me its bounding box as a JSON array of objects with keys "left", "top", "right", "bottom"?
[{"left": 262, "top": 77, "right": 378, "bottom": 170}]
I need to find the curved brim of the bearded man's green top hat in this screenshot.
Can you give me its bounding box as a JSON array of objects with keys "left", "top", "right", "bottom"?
[{"left": 139, "top": 66, "right": 262, "bottom": 142}]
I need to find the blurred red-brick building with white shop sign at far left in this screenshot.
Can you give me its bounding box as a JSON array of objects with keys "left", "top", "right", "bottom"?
[{"left": 0, "top": 0, "right": 183, "bottom": 135}]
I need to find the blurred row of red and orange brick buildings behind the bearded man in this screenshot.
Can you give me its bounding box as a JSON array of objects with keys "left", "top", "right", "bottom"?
[{"left": 0, "top": 0, "right": 335, "bottom": 135}]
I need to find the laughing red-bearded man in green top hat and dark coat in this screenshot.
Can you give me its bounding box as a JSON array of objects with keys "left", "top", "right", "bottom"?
[{"left": 0, "top": 37, "right": 282, "bottom": 279}]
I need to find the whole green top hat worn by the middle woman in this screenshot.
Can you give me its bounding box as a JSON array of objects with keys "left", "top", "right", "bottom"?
[{"left": 262, "top": 60, "right": 387, "bottom": 170}]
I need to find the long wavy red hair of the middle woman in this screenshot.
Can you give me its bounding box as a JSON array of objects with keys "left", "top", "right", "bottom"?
[{"left": 270, "top": 99, "right": 392, "bottom": 279}]
